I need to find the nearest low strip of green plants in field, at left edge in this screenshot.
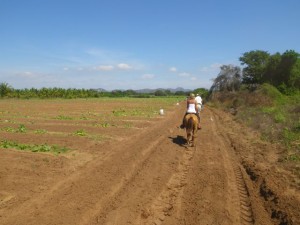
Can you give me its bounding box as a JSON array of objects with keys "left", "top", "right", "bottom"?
[{"left": 0, "top": 140, "right": 68, "bottom": 154}]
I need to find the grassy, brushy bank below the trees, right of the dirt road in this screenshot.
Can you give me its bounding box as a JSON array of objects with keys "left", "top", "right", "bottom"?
[{"left": 210, "top": 84, "right": 300, "bottom": 151}]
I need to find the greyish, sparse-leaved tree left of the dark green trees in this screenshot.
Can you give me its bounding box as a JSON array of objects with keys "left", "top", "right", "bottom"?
[{"left": 211, "top": 65, "right": 242, "bottom": 91}]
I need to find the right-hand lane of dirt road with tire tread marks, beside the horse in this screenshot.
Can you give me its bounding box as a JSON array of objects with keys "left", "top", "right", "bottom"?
[{"left": 169, "top": 107, "right": 254, "bottom": 225}]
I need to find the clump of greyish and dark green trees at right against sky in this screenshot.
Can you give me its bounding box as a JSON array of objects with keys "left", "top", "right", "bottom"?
[{"left": 210, "top": 50, "right": 300, "bottom": 94}]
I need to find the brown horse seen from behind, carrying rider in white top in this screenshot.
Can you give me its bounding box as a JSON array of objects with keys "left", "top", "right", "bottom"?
[{"left": 184, "top": 114, "right": 198, "bottom": 147}]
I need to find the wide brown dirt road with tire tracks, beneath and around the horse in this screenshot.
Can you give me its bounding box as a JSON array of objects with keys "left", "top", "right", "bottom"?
[{"left": 2, "top": 104, "right": 253, "bottom": 225}]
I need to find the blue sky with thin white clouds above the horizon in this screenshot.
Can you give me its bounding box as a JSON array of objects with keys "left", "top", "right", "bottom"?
[{"left": 0, "top": 0, "right": 300, "bottom": 90}]
